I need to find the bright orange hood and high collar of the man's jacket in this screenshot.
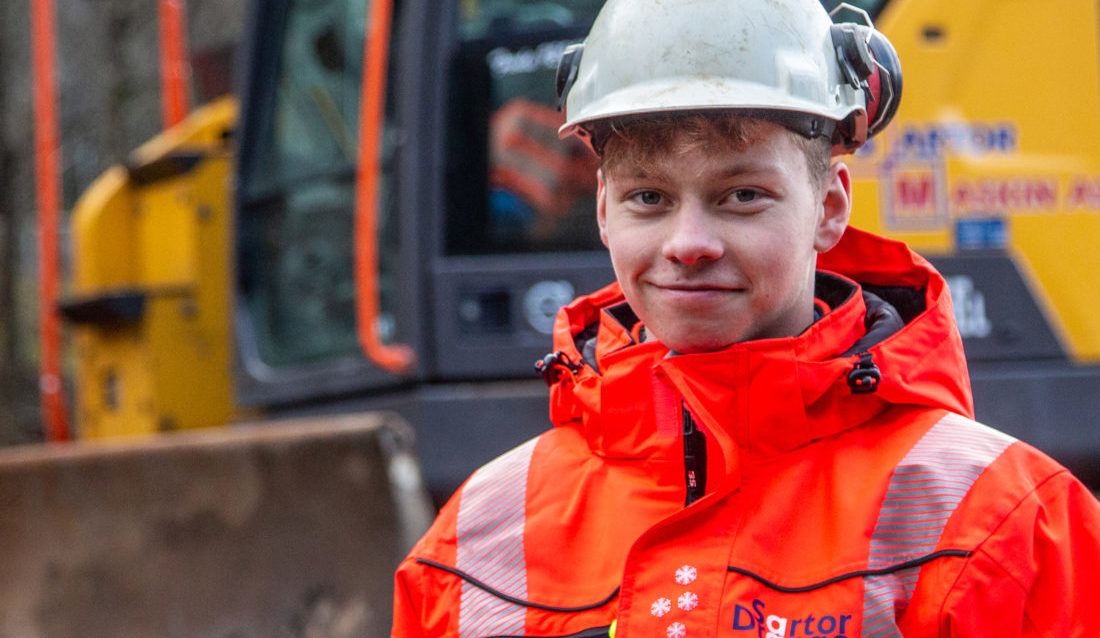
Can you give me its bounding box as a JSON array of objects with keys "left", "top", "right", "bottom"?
[{"left": 542, "top": 228, "right": 974, "bottom": 484}]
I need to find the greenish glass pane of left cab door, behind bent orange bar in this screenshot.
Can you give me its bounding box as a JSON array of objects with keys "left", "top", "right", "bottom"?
[{"left": 239, "top": 0, "right": 402, "bottom": 367}]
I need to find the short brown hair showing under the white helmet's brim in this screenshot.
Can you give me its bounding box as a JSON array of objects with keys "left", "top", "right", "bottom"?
[{"left": 600, "top": 111, "right": 832, "bottom": 189}]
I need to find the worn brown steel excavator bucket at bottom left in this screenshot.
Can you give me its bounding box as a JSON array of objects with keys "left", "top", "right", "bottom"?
[{"left": 0, "top": 413, "right": 432, "bottom": 638}]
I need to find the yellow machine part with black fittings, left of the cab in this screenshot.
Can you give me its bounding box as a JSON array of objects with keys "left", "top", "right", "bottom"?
[{"left": 64, "top": 99, "right": 237, "bottom": 437}]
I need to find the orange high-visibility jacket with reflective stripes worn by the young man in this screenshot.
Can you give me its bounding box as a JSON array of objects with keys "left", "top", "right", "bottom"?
[{"left": 393, "top": 229, "right": 1100, "bottom": 638}]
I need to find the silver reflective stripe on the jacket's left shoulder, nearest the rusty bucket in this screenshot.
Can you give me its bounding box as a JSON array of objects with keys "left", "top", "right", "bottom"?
[{"left": 455, "top": 439, "right": 537, "bottom": 638}]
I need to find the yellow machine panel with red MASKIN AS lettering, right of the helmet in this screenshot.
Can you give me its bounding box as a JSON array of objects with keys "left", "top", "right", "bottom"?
[{"left": 849, "top": 0, "right": 1100, "bottom": 363}]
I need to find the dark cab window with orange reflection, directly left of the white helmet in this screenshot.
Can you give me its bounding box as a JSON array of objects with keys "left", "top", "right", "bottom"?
[{"left": 443, "top": 0, "right": 603, "bottom": 255}]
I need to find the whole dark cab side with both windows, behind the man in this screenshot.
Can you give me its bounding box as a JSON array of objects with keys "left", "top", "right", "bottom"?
[{"left": 237, "top": 0, "right": 613, "bottom": 407}]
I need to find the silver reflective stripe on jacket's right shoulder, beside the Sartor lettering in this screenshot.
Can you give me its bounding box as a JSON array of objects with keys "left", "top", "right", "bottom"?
[{"left": 862, "top": 415, "right": 1015, "bottom": 638}]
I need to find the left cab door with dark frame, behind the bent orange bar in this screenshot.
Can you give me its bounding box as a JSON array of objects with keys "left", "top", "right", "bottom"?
[{"left": 235, "top": 0, "right": 422, "bottom": 405}]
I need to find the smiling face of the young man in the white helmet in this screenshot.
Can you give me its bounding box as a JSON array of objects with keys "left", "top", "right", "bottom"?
[{"left": 597, "top": 122, "right": 850, "bottom": 353}]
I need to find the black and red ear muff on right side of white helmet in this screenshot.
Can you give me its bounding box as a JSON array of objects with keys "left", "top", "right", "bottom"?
[{"left": 832, "top": 23, "right": 902, "bottom": 146}]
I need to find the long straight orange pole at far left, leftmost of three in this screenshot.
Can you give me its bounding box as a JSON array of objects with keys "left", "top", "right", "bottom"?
[{"left": 31, "top": 0, "right": 69, "bottom": 441}]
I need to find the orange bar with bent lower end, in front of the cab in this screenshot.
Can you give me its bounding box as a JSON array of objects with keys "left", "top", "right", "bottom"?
[{"left": 355, "top": 0, "right": 416, "bottom": 374}]
